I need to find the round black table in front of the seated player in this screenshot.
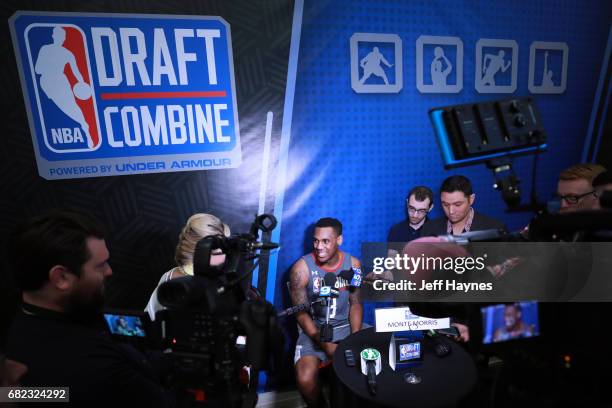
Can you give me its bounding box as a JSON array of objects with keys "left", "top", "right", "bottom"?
[{"left": 333, "top": 327, "right": 476, "bottom": 407}]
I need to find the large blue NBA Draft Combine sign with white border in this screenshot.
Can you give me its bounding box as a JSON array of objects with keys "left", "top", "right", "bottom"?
[{"left": 10, "top": 12, "right": 241, "bottom": 179}]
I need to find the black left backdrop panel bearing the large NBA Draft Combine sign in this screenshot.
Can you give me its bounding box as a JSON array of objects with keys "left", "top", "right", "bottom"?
[{"left": 0, "top": 0, "right": 294, "bottom": 329}]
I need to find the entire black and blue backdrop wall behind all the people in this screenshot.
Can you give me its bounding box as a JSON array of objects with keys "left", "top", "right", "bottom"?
[{"left": 0, "top": 0, "right": 612, "bottom": 396}]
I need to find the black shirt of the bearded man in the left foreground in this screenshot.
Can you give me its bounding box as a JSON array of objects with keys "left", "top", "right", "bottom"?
[{"left": 6, "top": 304, "right": 169, "bottom": 407}]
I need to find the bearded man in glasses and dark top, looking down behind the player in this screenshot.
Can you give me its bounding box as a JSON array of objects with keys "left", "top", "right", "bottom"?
[{"left": 387, "top": 186, "right": 433, "bottom": 257}]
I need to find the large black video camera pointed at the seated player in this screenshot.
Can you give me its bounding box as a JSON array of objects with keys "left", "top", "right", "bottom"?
[{"left": 107, "top": 214, "right": 283, "bottom": 407}]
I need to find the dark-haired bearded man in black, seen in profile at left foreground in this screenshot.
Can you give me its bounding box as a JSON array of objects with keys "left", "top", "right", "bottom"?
[{"left": 6, "top": 211, "right": 168, "bottom": 407}]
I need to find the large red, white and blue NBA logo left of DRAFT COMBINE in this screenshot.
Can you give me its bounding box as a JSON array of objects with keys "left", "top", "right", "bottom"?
[{"left": 24, "top": 23, "right": 101, "bottom": 153}]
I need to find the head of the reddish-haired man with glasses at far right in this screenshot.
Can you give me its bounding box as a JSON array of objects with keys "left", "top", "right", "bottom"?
[{"left": 557, "top": 163, "right": 606, "bottom": 214}]
